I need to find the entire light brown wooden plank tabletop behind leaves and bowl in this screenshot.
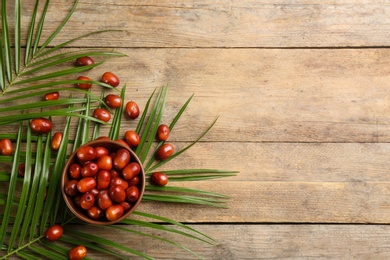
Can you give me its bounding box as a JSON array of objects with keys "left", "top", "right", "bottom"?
[{"left": 8, "top": 0, "right": 390, "bottom": 259}]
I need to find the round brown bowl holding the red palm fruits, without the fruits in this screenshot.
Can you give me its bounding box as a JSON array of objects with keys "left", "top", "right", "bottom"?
[{"left": 61, "top": 139, "right": 145, "bottom": 225}]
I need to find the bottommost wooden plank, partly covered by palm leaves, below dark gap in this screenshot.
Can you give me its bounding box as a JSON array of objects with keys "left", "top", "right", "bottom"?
[{"left": 77, "top": 224, "right": 390, "bottom": 260}]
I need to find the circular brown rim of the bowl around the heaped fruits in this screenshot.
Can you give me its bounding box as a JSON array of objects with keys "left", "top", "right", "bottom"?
[{"left": 61, "top": 139, "right": 146, "bottom": 225}]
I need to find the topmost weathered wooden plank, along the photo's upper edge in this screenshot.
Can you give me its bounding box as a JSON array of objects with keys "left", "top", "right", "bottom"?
[{"left": 9, "top": 0, "right": 390, "bottom": 48}]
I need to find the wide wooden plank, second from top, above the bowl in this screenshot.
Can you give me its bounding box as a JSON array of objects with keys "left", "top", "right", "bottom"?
[{"left": 3, "top": 49, "right": 390, "bottom": 142}]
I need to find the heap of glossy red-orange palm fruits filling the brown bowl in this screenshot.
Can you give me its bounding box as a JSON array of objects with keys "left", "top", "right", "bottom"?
[{"left": 63, "top": 141, "right": 144, "bottom": 222}]
